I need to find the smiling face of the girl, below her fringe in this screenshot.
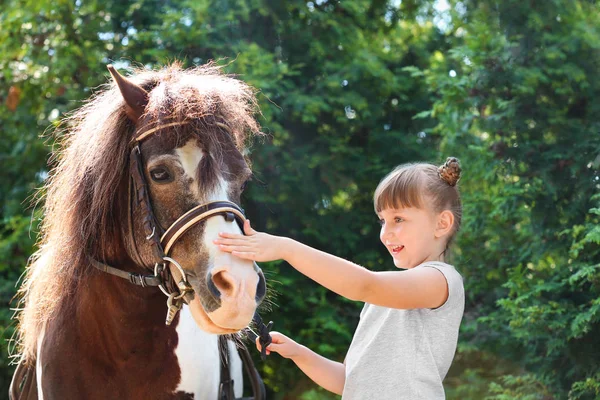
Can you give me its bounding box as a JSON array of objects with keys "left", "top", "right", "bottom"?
[{"left": 378, "top": 207, "right": 444, "bottom": 269}]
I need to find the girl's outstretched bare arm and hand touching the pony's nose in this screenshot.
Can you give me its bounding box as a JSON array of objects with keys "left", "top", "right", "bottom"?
[{"left": 215, "top": 221, "right": 448, "bottom": 309}]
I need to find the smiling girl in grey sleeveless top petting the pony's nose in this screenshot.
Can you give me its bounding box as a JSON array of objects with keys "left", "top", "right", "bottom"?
[{"left": 215, "top": 158, "right": 464, "bottom": 400}]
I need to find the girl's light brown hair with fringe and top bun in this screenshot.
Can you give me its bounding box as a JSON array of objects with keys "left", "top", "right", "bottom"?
[{"left": 373, "top": 157, "right": 462, "bottom": 248}]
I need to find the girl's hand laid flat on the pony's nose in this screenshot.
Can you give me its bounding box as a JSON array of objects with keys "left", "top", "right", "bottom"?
[{"left": 213, "top": 220, "right": 283, "bottom": 262}]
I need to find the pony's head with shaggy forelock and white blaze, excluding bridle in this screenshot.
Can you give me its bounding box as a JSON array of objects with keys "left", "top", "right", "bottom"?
[{"left": 109, "top": 67, "right": 265, "bottom": 334}]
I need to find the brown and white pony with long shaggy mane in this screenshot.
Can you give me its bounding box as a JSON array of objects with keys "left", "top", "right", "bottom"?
[{"left": 11, "top": 63, "right": 266, "bottom": 400}]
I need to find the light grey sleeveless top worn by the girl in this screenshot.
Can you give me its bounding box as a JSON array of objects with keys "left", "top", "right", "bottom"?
[{"left": 342, "top": 262, "right": 465, "bottom": 400}]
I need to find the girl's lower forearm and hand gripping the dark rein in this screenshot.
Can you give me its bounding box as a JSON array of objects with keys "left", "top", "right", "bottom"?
[{"left": 256, "top": 332, "right": 346, "bottom": 395}]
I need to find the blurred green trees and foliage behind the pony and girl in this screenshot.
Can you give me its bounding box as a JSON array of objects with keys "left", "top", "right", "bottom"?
[{"left": 0, "top": 0, "right": 600, "bottom": 400}]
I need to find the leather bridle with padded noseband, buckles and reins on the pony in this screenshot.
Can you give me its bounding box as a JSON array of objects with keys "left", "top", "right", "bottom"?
[{"left": 89, "top": 122, "right": 273, "bottom": 400}]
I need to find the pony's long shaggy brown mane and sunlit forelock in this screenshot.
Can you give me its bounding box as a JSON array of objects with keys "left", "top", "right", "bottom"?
[{"left": 15, "top": 64, "right": 260, "bottom": 362}]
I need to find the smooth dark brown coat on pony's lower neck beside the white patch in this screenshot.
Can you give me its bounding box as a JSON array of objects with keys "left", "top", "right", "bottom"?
[{"left": 38, "top": 264, "right": 181, "bottom": 399}]
